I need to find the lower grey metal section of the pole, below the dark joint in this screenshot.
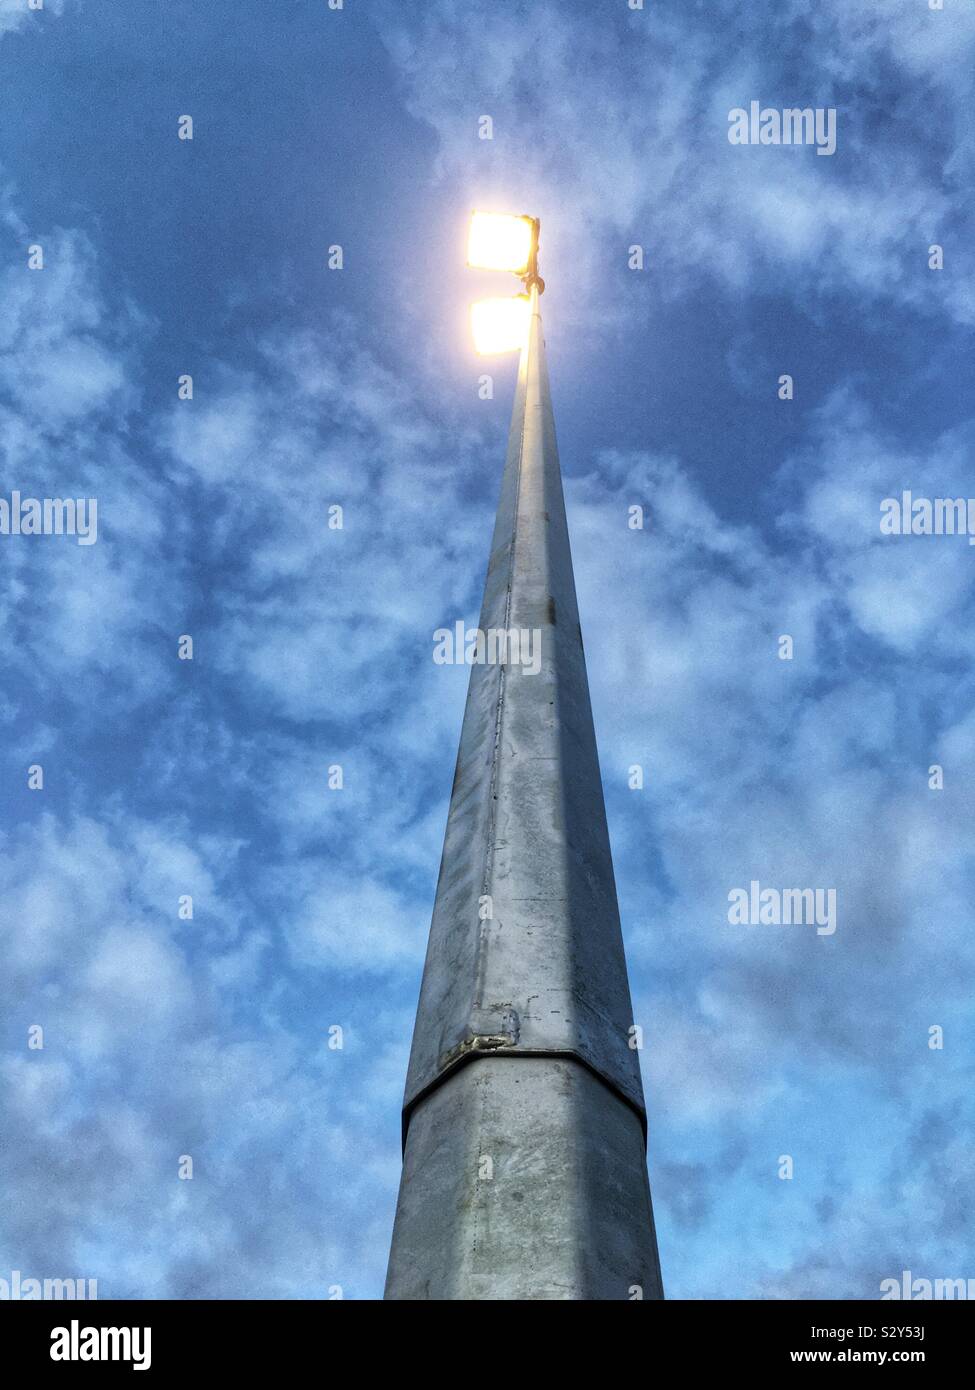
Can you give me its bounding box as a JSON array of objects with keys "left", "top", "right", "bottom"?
[{"left": 385, "top": 1055, "right": 662, "bottom": 1301}]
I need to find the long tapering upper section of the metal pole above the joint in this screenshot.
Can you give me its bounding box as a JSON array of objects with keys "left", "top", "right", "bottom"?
[{"left": 406, "top": 287, "right": 643, "bottom": 1113}]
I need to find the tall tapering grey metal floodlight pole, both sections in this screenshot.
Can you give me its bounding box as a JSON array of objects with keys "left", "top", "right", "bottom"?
[{"left": 385, "top": 275, "right": 663, "bottom": 1300}]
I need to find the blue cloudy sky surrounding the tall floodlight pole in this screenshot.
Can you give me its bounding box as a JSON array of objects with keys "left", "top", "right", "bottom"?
[{"left": 0, "top": 0, "right": 975, "bottom": 1298}]
